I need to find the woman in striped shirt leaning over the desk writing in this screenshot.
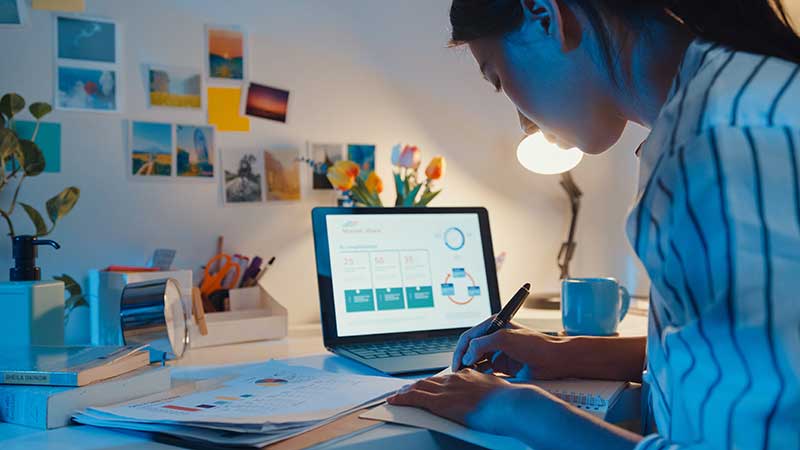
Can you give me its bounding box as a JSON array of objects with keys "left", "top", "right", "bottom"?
[{"left": 390, "top": 0, "right": 800, "bottom": 449}]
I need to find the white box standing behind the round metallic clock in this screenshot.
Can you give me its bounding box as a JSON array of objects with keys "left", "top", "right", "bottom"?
[{"left": 86, "top": 270, "right": 192, "bottom": 345}]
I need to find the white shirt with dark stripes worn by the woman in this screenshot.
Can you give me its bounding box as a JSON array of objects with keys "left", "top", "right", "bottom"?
[{"left": 627, "top": 41, "right": 800, "bottom": 450}]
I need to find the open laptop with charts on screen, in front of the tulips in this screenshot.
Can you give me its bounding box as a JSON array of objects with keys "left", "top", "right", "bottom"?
[{"left": 311, "top": 208, "right": 500, "bottom": 375}]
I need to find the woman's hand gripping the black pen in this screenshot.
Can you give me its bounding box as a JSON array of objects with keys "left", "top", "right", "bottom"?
[{"left": 452, "top": 317, "right": 568, "bottom": 379}]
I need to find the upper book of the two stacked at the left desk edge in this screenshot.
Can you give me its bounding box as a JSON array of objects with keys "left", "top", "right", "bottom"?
[{"left": 0, "top": 345, "right": 150, "bottom": 386}]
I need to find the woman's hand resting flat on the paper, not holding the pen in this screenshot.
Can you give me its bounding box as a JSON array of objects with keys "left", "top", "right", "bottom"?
[{"left": 387, "top": 369, "right": 520, "bottom": 431}]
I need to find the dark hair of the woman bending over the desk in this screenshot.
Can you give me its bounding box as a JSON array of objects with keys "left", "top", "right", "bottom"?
[{"left": 450, "top": 0, "right": 800, "bottom": 70}]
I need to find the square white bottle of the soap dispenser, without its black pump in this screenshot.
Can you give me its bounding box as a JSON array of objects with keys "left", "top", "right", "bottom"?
[{"left": 0, "top": 281, "right": 64, "bottom": 346}]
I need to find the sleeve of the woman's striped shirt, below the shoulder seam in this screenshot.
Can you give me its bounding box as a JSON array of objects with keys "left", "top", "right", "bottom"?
[{"left": 637, "top": 127, "right": 800, "bottom": 450}]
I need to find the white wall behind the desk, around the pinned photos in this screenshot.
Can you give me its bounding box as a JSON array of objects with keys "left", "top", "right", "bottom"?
[{"left": 0, "top": 0, "right": 645, "bottom": 334}]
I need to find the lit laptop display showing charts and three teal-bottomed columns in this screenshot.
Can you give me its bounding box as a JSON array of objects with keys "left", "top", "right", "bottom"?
[{"left": 326, "top": 213, "right": 491, "bottom": 337}]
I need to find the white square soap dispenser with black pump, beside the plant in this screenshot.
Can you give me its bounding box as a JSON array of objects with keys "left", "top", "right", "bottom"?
[{"left": 0, "top": 235, "right": 64, "bottom": 346}]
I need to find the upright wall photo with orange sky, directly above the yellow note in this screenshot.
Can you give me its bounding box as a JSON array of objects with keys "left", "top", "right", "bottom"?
[{"left": 206, "top": 25, "right": 245, "bottom": 80}]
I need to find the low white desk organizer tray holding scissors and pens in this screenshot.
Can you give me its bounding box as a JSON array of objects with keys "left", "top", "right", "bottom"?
[{"left": 189, "top": 286, "right": 289, "bottom": 348}]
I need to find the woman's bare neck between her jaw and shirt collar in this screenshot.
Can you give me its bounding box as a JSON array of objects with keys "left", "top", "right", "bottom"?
[{"left": 620, "top": 20, "right": 694, "bottom": 128}]
